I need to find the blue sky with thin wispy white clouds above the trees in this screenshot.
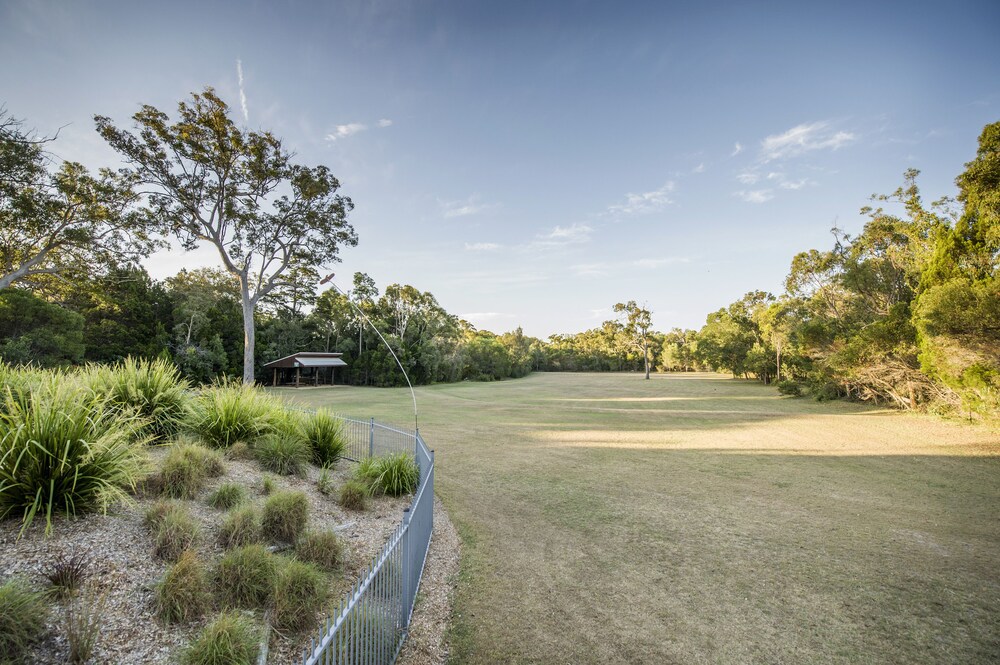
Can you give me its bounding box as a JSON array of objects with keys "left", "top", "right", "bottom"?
[{"left": 0, "top": 0, "right": 1000, "bottom": 337}]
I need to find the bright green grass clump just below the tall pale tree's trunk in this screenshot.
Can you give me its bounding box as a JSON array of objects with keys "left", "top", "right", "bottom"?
[{"left": 191, "top": 383, "right": 283, "bottom": 448}]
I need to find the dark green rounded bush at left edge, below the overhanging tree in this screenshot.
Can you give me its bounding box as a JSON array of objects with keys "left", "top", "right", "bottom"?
[{"left": 0, "top": 288, "right": 85, "bottom": 367}]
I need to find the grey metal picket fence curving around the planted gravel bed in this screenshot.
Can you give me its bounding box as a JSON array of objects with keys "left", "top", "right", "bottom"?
[{"left": 302, "top": 418, "right": 434, "bottom": 665}]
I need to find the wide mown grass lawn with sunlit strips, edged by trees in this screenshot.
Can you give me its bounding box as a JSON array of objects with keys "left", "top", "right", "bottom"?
[{"left": 280, "top": 374, "right": 1000, "bottom": 664}]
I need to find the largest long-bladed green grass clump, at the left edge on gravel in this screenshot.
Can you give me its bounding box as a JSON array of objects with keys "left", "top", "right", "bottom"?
[{"left": 0, "top": 375, "right": 146, "bottom": 533}]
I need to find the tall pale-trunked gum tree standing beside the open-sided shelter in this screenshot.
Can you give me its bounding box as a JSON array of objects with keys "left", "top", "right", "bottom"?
[{"left": 95, "top": 88, "right": 357, "bottom": 383}]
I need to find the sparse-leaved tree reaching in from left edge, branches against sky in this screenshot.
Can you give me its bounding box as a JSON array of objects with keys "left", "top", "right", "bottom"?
[{"left": 0, "top": 109, "right": 158, "bottom": 289}]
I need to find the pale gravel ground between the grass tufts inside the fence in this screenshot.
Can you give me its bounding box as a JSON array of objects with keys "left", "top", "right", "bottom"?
[{"left": 0, "top": 448, "right": 412, "bottom": 665}]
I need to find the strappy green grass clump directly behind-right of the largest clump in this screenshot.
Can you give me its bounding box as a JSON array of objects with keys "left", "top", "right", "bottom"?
[{"left": 91, "top": 357, "right": 192, "bottom": 439}]
